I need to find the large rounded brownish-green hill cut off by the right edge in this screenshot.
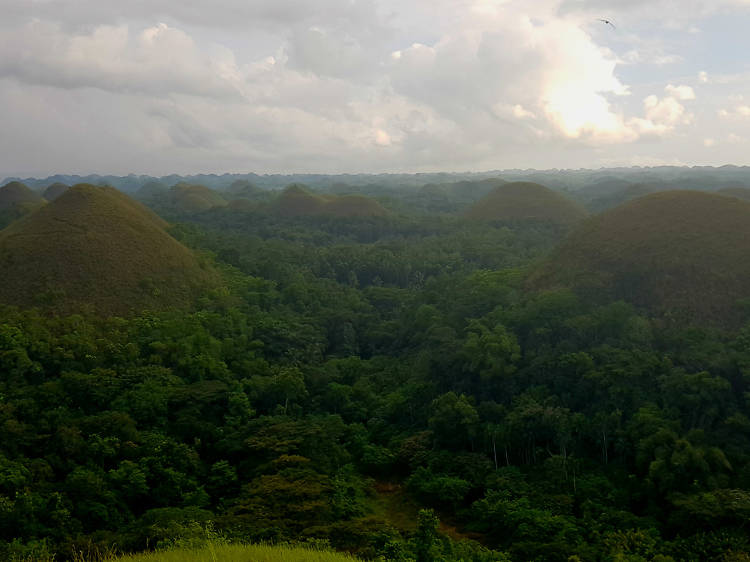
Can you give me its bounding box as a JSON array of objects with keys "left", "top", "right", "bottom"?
[{"left": 530, "top": 191, "right": 750, "bottom": 325}]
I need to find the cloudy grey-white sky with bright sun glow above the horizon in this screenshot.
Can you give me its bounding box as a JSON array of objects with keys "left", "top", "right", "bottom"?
[{"left": 0, "top": 0, "right": 750, "bottom": 177}]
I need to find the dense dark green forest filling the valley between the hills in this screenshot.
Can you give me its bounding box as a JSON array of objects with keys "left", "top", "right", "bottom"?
[{"left": 0, "top": 176, "right": 750, "bottom": 562}]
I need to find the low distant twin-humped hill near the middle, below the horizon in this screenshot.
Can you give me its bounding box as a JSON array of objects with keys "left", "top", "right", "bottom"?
[{"left": 271, "top": 184, "right": 388, "bottom": 217}]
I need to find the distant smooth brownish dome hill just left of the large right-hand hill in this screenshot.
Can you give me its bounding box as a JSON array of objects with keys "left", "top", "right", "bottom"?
[{"left": 465, "top": 182, "right": 586, "bottom": 226}]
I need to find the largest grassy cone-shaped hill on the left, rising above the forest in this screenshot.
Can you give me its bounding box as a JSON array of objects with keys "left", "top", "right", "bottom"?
[{"left": 0, "top": 184, "right": 215, "bottom": 315}]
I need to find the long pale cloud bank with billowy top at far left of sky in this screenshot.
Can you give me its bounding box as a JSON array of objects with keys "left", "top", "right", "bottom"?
[{"left": 0, "top": 21, "right": 242, "bottom": 96}]
